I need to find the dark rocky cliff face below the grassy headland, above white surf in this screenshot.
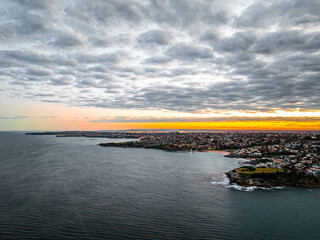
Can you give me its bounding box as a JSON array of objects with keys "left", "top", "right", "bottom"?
[{"left": 226, "top": 170, "right": 320, "bottom": 187}]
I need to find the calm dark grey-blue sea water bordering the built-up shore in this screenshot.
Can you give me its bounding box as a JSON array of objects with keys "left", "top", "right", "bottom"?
[{"left": 0, "top": 133, "right": 320, "bottom": 239}]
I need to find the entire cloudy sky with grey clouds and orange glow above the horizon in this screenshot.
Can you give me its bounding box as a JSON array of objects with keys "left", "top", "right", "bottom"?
[{"left": 0, "top": 0, "right": 320, "bottom": 131}]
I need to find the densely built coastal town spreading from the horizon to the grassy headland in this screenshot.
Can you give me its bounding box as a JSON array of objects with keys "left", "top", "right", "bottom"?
[{"left": 28, "top": 131, "right": 320, "bottom": 186}]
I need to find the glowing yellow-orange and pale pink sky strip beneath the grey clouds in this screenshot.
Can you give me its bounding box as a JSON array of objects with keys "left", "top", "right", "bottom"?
[{"left": 0, "top": 94, "right": 320, "bottom": 131}]
